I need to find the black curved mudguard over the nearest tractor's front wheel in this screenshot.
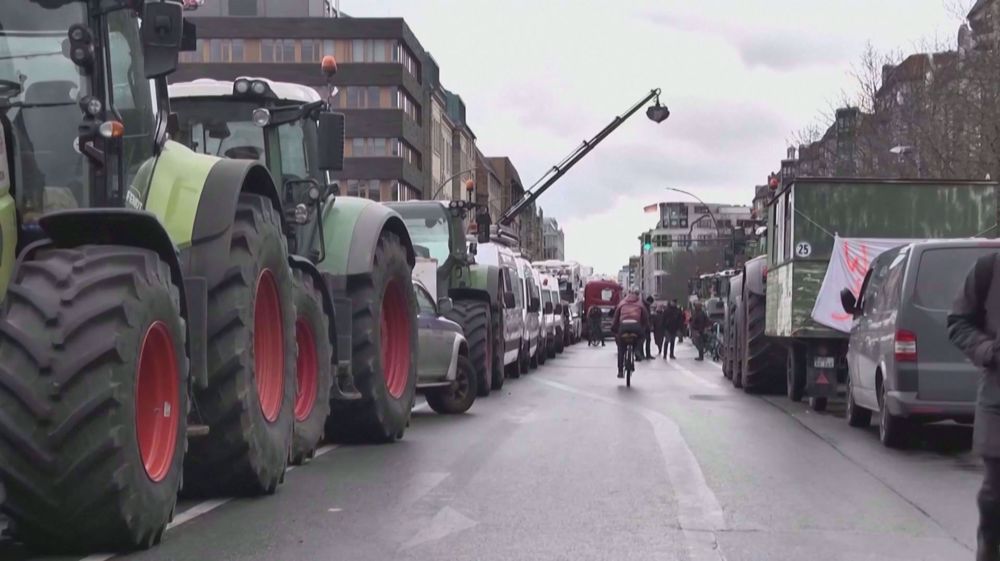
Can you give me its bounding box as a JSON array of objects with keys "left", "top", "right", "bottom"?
[{"left": 32, "top": 208, "right": 208, "bottom": 384}]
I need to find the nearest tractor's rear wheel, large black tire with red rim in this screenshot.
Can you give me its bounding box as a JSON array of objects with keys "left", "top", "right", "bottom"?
[{"left": 184, "top": 194, "right": 297, "bottom": 496}]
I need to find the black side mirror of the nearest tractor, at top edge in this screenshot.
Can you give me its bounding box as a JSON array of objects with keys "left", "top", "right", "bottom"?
[{"left": 141, "top": 2, "right": 185, "bottom": 79}]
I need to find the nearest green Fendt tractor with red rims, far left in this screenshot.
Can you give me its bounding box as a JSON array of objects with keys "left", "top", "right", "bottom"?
[{"left": 0, "top": 0, "right": 413, "bottom": 551}]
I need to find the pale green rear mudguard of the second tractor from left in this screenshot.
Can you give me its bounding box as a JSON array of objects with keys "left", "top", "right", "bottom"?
[{"left": 318, "top": 197, "right": 416, "bottom": 277}]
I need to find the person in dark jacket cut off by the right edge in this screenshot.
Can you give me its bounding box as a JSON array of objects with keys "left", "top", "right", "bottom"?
[{"left": 948, "top": 254, "right": 1000, "bottom": 561}]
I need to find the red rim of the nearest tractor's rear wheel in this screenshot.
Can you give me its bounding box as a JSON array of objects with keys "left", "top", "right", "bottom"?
[{"left": 253, "top": 269, "right": 285, "bottom": 423}]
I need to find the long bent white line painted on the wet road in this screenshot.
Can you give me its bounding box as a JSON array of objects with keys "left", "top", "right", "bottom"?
[{"left": 528, "top": 377, "right": 726, "bottom": 561}]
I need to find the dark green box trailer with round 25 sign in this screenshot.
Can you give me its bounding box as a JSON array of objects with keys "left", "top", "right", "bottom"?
[{"left": 752, "top": 178, "right": 998, "bottom": 409}]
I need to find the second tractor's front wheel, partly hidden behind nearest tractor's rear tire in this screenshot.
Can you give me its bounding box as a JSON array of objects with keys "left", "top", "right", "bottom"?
[{"left": 291, "top": 271, "right": 336, "bottom": 465}]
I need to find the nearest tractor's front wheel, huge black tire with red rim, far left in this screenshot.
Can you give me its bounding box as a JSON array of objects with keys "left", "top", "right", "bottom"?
[{"left": 0, "top": 246, "right": 188, "bottom": 553}]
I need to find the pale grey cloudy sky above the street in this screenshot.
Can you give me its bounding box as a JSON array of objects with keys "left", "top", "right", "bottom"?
[{"left": 350, "top": 0, "right": 971, "bottom": 273}]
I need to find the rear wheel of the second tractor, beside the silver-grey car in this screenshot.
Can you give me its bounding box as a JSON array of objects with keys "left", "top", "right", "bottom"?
[{"left": 326, "top": 232, "right": 417, "bottom": 442}]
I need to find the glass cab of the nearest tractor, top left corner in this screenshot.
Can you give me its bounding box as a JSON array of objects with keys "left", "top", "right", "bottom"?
[{"left": 0, "top": 0, "right": 194, "bottom": 232}]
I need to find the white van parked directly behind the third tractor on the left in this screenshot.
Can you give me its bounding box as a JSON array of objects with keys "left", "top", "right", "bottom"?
[{"left": 476, "top": 242, "right": 527, "bottom": 378}]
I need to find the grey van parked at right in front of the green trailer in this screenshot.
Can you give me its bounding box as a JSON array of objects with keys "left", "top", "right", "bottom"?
[{"left": 842, "top": 240, "right": 1000, "bottom": 447}]
